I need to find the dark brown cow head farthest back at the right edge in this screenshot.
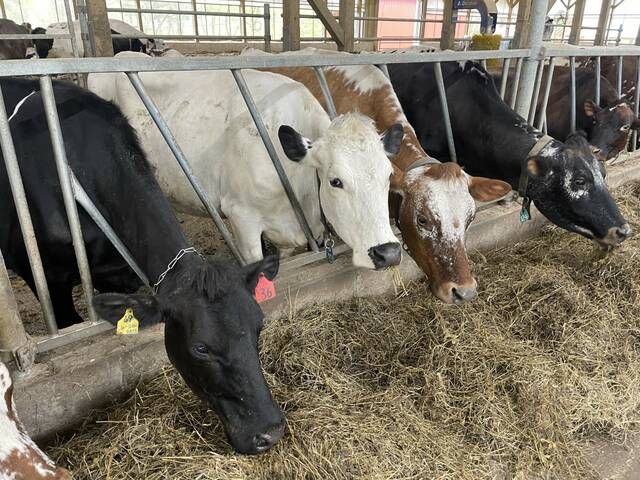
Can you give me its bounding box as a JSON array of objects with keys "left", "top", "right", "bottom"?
[{"left": 584, "top": 100, "right": 640, "bottom": 160}]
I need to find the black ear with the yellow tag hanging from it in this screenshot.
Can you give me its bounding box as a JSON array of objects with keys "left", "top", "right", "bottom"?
[{"left": 93, "top": 293, "right": 163, "bottom": 328}]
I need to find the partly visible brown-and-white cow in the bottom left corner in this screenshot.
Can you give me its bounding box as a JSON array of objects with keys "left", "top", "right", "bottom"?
[{"left": 0, "top": 362, "right": 71, "bottom": 480}]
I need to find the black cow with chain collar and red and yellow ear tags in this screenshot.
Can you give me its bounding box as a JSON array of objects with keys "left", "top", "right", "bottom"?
[{"left": 0, "top": 79, "right": 283, "bottom": 453}]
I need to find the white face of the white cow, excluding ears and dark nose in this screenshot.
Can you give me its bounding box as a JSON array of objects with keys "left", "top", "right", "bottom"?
[{"left": 310, "top": 113, "right": 397, "bottom": 268}]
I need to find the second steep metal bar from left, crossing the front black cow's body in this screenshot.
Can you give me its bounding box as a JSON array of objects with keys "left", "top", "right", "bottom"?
[{"left": 40, "top": 75, "right": 97, "bottom": 322}]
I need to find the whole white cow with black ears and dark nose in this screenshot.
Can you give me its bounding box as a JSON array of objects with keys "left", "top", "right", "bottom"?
[{"left": 89, "top": 52, "right": 402, "bottom": 268}]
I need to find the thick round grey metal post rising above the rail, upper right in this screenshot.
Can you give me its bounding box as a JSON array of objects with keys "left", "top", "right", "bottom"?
[{"left": 515, "top": 0, "right": 549, "bottom": 118}]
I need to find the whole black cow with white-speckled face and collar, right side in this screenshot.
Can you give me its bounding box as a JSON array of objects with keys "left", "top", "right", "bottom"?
[{"left": 389, "top": 62, "right": 631, "bottom": 246}]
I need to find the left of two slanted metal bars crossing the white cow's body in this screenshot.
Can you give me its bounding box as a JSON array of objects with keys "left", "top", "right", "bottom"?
[{"left": 127, "top": 72, "right": 246, "bottom": 265}]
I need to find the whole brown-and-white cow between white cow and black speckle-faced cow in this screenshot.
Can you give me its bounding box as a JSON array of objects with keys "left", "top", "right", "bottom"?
[{"left": 243, "top": 48, "right": 511, "bottom": 303}]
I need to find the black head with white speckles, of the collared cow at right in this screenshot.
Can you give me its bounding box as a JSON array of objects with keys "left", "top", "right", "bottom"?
[{"left": 526, "top": 133, "right": 631, "bottom": 247}]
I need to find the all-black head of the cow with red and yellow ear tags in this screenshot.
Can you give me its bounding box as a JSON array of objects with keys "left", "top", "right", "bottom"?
[{"left": 93, "top": 255, "right": 284, "bottom": 454}]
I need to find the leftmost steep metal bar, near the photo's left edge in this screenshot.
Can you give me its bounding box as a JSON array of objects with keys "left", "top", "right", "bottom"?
[{"left": 0, "top": 87, "right": 58, "bottom": 334}]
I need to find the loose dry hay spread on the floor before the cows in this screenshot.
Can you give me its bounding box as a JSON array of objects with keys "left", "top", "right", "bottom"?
[{"left": 51, "top": 185, "right": 640, "bottom": 480}]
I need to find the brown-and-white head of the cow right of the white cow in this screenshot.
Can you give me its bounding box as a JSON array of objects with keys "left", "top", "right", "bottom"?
[{"left": 391, "top": 162, "right": 511, "bottom": 304}]
